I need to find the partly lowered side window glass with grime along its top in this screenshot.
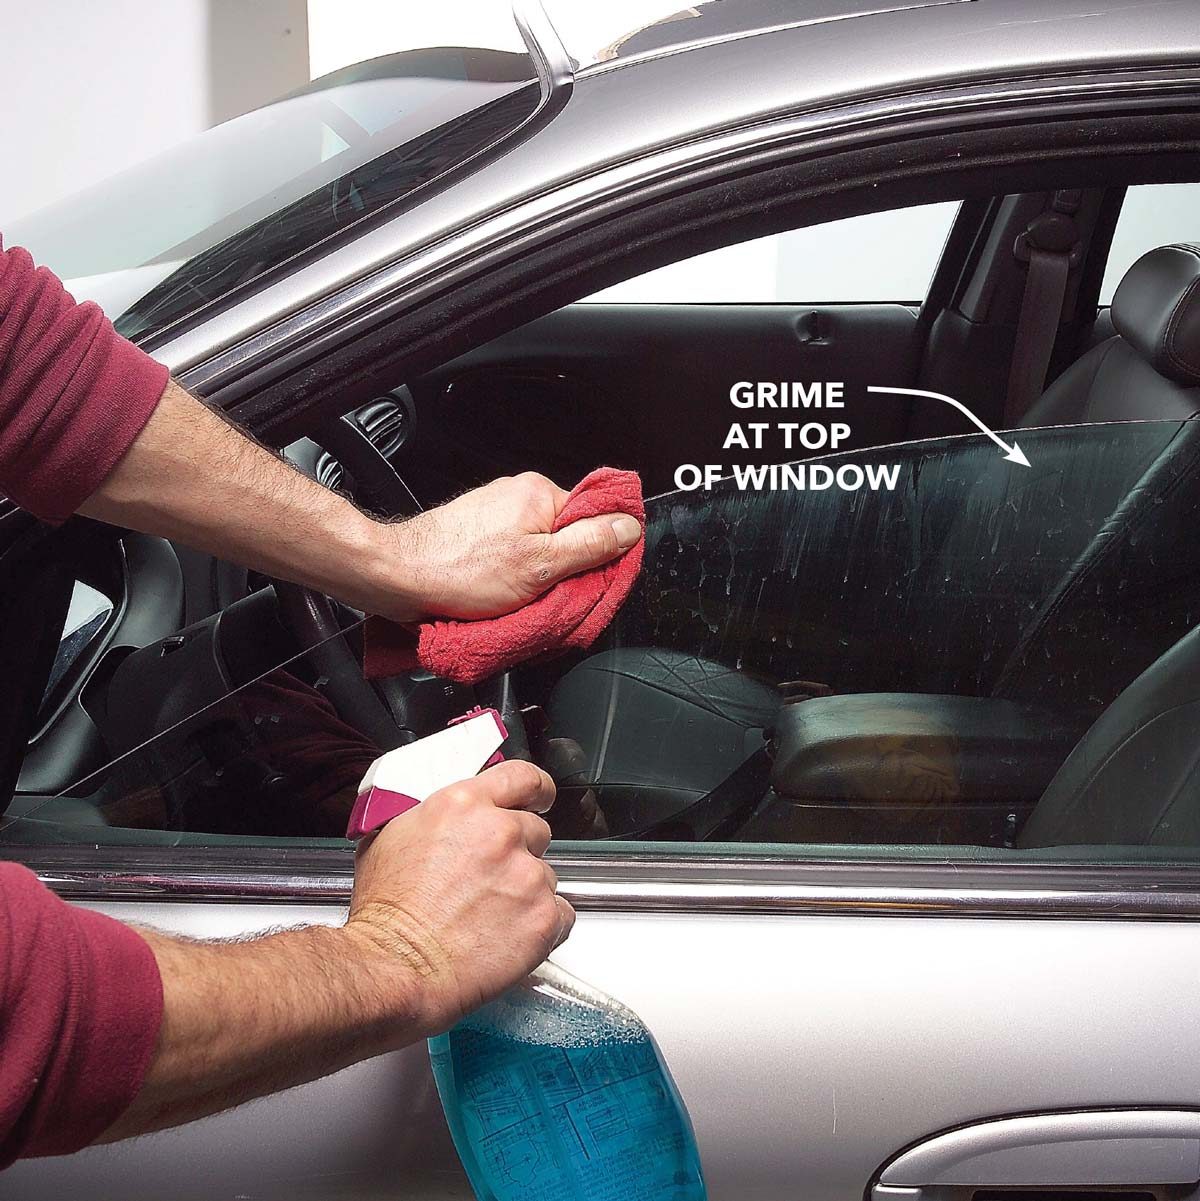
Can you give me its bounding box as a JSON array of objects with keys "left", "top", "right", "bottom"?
[{"left": 7, "top": 422, "right": 1200, "bottom": 860}]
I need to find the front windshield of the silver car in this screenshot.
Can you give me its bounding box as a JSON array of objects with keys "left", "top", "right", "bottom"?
[{"left": 5, "top": 48, "right": 539, "bottom": 337}]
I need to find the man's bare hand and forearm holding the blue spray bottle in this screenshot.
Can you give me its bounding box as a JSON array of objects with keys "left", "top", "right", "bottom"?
[{"left": 103, "top": 760, "right": 575, "bottom": 1142}]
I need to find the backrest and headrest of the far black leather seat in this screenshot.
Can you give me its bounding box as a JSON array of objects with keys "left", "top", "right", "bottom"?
[{"left": 939, "top": 245, "right": 1200, "bottom": 715}]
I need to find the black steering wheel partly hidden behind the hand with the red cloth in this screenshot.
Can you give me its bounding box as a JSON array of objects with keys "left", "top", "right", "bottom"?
[{"left": 274, "top": 416, "right": 531, "bottom": 759}]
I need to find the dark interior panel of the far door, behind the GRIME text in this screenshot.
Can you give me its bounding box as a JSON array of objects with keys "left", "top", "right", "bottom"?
[{"left": 404, "top": 304, "right": 921, "bottom": 503}]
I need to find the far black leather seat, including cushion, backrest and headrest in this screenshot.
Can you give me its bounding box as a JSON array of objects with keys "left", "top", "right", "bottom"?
[{"left": 548, "top": 245, "right": 1200, "bottom": 832}]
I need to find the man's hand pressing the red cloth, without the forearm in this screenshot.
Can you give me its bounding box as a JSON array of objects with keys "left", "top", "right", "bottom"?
[{"left": 368, "top": 471, "right": 641, "bottom": 621}]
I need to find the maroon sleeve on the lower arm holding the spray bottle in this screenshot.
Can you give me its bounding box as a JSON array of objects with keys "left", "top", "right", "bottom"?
[{"left": 0, "top": 864, "right": 162, "bottom": 1167}]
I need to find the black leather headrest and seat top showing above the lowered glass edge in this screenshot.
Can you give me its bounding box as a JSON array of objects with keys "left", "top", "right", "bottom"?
[{"left": 1020, "top": 245, "right": 1200, "bottom": 426}]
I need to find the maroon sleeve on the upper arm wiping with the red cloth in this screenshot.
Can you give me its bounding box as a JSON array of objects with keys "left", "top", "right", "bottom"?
[{"left": 0, "top": 236, "right": 167, "bottom": 521}]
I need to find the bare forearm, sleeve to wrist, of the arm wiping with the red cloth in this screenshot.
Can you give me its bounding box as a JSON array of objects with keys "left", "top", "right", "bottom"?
[{"left": 80, "top": 382, "right": 423, "bottom": 620}]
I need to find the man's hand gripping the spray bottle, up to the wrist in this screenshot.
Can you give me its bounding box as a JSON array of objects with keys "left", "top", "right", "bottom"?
[{"left": 346, "top": 759, "right": 575, "bottom": 1036}]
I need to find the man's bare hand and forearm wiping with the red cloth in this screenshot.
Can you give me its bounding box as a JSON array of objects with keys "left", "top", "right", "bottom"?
[{"left": 79, "top": 383, "right": 641, "bottom": 621}]
